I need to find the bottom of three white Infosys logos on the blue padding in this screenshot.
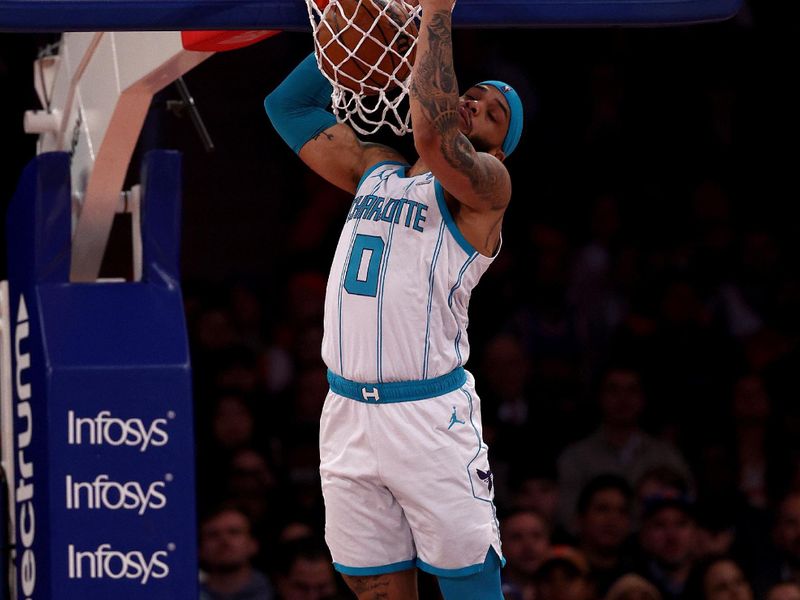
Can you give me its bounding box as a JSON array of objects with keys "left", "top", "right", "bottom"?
[{"left": 67, "top": 544, "right": 174, "bottom": 585}]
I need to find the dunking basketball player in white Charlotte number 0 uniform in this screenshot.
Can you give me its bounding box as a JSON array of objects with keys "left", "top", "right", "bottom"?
[{"left": 265, "top": 0, "right": 522, "bottom": 600}]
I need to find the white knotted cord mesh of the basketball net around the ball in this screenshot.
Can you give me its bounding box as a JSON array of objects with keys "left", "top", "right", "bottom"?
[{"left": 306, "top": 0, "right": 422, "bottom": 135}]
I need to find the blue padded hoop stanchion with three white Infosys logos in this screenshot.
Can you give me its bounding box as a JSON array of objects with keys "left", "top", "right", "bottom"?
[{"left": 7, "top": 152, "right": 198, "bottom": 600}]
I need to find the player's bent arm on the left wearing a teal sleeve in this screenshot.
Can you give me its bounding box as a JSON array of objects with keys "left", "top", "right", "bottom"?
[{"left": 264, "top": 54, "right": 404, "bottom": 192}]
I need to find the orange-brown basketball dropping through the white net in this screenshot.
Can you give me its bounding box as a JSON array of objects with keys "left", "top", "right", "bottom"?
[{"left": 316, "top": 0, "right": 418, "bottom": 96}]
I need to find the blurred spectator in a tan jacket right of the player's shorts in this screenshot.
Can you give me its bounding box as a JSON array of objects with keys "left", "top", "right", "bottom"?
[{"left": 558, "top": 367, "right": 690, "bottom": 531}]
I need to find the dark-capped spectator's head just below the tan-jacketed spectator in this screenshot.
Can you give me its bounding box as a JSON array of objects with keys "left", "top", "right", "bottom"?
[{"left": 639, "top": 496, "right": 696, "bottom": 600}]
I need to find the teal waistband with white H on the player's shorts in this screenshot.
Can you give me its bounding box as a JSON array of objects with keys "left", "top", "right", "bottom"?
[{"left": 328, "top": 367, "right": 467, "bottom": 404}]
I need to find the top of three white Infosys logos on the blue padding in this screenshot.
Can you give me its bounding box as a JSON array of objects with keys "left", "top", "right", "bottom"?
[{"left": 67, "top": 410, "right": 174, "bottom": 452}]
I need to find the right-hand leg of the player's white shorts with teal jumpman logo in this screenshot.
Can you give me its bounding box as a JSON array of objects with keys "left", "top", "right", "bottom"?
[{"left": 375, "top": 385, "right": 501, "bottom": 576}]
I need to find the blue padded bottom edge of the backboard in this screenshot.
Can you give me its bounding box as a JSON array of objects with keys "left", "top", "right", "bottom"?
[{"left": 0, "top": 0, "right": 742, "bottom": 32}]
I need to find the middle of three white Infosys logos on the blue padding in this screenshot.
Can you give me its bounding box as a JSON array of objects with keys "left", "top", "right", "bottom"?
[{"left": 66, "top": 473, "right": 172, "bottom": 516}]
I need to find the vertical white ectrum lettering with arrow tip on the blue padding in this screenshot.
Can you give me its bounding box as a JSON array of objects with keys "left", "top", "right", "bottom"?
[{"left": 14, "top": 295, "right": 36, "bottom": 599}]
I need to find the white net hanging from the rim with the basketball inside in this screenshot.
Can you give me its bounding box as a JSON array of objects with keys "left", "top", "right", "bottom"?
[{"left": 306, "top": 0, "right": 421, "bottom": 135}]
